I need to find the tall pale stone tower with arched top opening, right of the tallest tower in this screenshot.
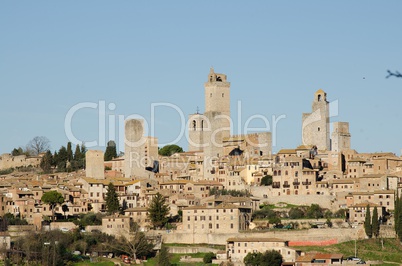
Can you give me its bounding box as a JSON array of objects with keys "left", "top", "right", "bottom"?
[{"left": 302, "top": 89, "right": 331, "bottom": 151}]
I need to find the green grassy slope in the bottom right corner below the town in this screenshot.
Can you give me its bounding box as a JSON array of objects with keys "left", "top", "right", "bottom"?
[{"left": 294, "top": 239, "right": 402, "bottom": 265}]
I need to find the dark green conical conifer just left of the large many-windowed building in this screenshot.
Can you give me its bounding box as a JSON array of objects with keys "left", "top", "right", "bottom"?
[{"left": 148, "top": 192, "right": 170, "bottom": 229}]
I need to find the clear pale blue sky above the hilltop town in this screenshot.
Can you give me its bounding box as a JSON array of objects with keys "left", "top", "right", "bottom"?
[{"left": 0, "top": 0, "right": 402, "bottom": 155}]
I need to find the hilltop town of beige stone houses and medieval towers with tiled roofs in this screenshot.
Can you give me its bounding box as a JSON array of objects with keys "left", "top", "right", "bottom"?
[{"left": 0, "top": 68, "right": 402, "bottom": 265}]
